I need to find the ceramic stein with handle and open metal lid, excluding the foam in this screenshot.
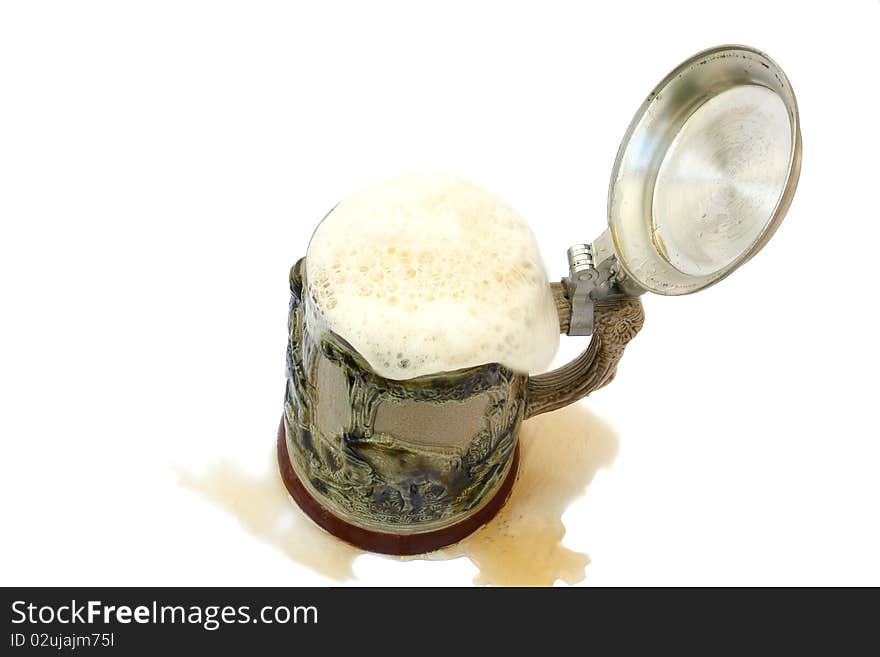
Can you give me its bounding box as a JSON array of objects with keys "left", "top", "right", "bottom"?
[{"left": 277, "top": 46, "right": 801, "bottom": 555}]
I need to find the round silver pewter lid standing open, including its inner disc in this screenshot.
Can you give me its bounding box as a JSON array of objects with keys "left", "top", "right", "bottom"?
[{"left": 608, "top": 46, "right": 801, "bottom": 295}]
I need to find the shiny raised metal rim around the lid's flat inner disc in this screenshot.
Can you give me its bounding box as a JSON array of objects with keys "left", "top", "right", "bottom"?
[{"left": 608, "top": 45, "right": 801, "bottom": 295}]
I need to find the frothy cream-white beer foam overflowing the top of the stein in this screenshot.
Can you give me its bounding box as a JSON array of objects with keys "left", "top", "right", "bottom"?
[{"left": 306, "top": 174, "right": 559, "bottom": 379}]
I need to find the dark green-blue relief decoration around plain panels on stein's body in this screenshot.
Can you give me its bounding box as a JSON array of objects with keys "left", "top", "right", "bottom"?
[{"left": 284, "top": 258, "right": 527, "bottom": 532}]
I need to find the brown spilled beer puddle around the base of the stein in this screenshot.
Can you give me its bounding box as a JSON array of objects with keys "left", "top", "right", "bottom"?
[{"left": 180, "top": 405, "right": 617, "bottom": 586}]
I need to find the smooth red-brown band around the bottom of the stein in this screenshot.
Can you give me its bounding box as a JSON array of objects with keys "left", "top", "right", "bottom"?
[{"left": 278, "top": 418, "right": 519, "bottom": 555}]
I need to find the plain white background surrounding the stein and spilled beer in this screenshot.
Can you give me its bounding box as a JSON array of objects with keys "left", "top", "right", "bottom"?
[{"left": 0, "top": 0, "right": 880, "bottom": 585}]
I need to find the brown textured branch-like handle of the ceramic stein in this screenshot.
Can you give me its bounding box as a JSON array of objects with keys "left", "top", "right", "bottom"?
[{"left": 525, "top": 283, "right": 645, "bottom": 418}]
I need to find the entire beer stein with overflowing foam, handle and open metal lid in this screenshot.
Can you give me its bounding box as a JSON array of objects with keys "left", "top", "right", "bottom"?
[{"left": 278, "top": 46, "right": 800, "bottom": 554}]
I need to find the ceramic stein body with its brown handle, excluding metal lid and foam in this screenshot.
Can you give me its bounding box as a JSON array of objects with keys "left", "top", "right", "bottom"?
[{"left": 278, "top": 261, "right": 643, "bottom": 554}]
